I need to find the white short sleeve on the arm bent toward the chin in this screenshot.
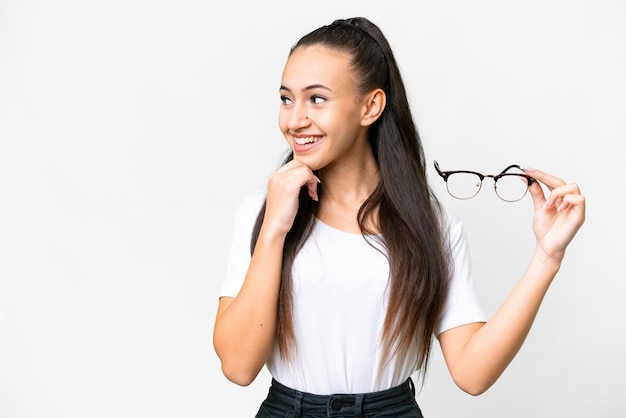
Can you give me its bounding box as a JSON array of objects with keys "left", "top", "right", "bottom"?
[{"left": 219, "top": 191, "right": 266, "bottom": 297}]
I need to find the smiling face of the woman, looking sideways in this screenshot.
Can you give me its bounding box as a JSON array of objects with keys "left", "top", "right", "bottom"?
[{"left": 279, "top": 45, "right": 369, "bottom": 170}]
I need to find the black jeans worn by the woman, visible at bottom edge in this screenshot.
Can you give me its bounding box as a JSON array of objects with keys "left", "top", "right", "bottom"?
[{"left": 256, "top": 378, "right": 423, "bottom": 418}]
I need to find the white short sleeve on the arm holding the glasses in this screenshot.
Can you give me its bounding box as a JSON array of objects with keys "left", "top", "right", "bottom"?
[{"left": 435, "top": 208, "right": 486, "bottom": 335}]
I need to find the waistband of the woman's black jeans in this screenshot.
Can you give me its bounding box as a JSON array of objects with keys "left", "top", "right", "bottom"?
[{"left": 268, "top": 378, "right": 415, "bottom": 417}]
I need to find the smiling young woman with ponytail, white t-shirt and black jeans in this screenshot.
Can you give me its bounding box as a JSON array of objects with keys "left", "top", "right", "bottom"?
[{"left": 214, "top": 18, "right": 585, "bottom": 418}]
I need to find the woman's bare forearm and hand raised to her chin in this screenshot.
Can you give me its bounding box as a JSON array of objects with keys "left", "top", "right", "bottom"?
[{"left": 213, "top": 160, "right": 318, "bottom": 385}]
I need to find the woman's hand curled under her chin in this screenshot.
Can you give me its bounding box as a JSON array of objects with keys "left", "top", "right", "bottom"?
[{"left": 263, "top": 159, "right": 320, "bottom": 235}]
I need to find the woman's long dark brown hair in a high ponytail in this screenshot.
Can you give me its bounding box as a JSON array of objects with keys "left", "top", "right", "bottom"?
[{"left": 251, "top": 17, "right": 451, "bottom": 372}]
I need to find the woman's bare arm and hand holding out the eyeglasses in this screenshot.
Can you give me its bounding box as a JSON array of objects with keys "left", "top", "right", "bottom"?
[{"left": 438, "top": 170, "right": 585, "bottom": 395}]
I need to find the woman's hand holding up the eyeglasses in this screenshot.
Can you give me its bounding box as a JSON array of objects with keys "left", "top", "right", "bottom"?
[{"left": 525, "top": 169, "right": 585, "bottom": 261}]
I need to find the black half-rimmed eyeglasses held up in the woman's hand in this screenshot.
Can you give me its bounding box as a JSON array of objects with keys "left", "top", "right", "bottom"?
[{"left": 435, "top": 161, "right": 535, "bottom": 202}]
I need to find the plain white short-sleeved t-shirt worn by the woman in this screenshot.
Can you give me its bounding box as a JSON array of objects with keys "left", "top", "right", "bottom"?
[{"left": 220, "top": 191, "right": 485, "bottom": 395}]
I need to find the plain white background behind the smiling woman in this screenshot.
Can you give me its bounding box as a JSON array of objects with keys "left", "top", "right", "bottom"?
[{"left": 0, "top": 0, "right": 626, "bottom": 418}]
